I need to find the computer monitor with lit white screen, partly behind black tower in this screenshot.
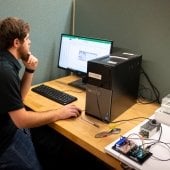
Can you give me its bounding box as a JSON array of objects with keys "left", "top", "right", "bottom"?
[{"left": 58, "top": 34, "right": 113, "bottom": 88}]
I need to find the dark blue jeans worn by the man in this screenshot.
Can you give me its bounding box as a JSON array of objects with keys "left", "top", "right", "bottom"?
[{"left": 0, "top": 129, "right": 42, "bottom": 170}]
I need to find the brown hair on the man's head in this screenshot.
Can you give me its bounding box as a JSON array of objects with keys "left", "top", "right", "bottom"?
[{"left": 0, "top": 17, "right": 30, "bottom": 50}]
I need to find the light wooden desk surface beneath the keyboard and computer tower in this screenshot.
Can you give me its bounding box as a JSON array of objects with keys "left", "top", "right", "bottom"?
[{"left": 24, "top": 76, "right": 159, "bottom": 169}]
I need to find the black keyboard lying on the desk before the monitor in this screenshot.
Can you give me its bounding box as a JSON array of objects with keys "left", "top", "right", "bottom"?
[{"left": 31, "top": 84, "right": 77, "bottom": 105}]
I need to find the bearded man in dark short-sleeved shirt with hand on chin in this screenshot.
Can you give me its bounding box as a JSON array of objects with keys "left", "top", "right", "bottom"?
[{"left": 0, "top": 17, "right": 81, "bottom": 170}]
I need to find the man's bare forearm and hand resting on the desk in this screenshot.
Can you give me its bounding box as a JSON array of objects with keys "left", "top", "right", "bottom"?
[{"left": 9, "top": 105, "right": 81, "bottom": 128}]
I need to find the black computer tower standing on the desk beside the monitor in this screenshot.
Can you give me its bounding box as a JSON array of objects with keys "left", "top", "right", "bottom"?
[{"left": 85, "top": 48, "right": 142, "bottom": 123}]
